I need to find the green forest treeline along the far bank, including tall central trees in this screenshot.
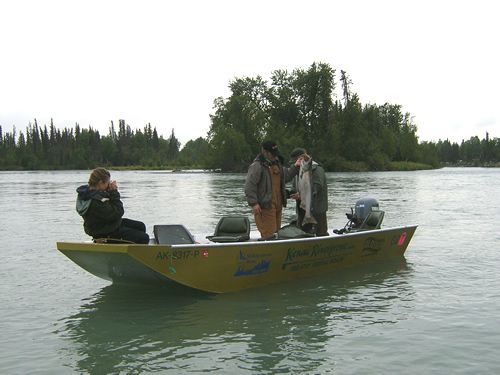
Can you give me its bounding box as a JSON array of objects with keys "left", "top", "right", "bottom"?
[{"left": 0, "top": 63, "right": 500, "bottom": 171}]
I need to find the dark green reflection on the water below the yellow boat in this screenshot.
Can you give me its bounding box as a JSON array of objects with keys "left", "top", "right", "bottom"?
[{"left": 57, "top": 258, "right": 414, "bottom": 374}]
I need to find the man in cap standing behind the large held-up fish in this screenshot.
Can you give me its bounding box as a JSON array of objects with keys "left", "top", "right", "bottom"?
[{"left": 288, "top": 147, "right": 328, "bottom": 236}]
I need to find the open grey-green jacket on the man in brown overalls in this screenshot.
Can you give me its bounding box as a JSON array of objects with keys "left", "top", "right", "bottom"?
[{"left": 245, "top": 154, "right": 299, "bottom": 208}]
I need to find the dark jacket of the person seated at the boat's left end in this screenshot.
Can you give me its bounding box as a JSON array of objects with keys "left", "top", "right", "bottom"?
[{"left": 76, "top": 185, "right": 124, "bottom": 238}]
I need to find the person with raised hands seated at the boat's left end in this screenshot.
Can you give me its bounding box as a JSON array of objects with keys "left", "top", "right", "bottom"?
[{"left": 76, "top": 168, "right": 149, "bottom": 244}]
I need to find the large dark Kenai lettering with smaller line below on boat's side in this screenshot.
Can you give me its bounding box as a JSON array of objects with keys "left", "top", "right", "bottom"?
[{"left": 281, "top": 244, "right": 354, "bottom": 271}]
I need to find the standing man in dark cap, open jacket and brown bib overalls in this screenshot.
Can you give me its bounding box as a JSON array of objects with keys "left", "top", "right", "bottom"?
[{"left": 245, "top": 141, "right": 300, "bottom": 238}]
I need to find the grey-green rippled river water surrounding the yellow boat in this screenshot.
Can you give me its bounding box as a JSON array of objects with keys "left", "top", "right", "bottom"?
[{"left": 0, "top": 168, "right": 500, "bottom": 374}]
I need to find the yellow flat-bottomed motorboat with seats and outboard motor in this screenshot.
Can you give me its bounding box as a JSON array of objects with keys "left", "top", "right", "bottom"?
[{"left": 57, "top": 200, "right": 417, "bottom": 293}]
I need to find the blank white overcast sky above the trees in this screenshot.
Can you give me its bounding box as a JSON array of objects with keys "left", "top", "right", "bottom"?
[{"left": 0, "top": 0, "right": 500, "bottom": 144}]
